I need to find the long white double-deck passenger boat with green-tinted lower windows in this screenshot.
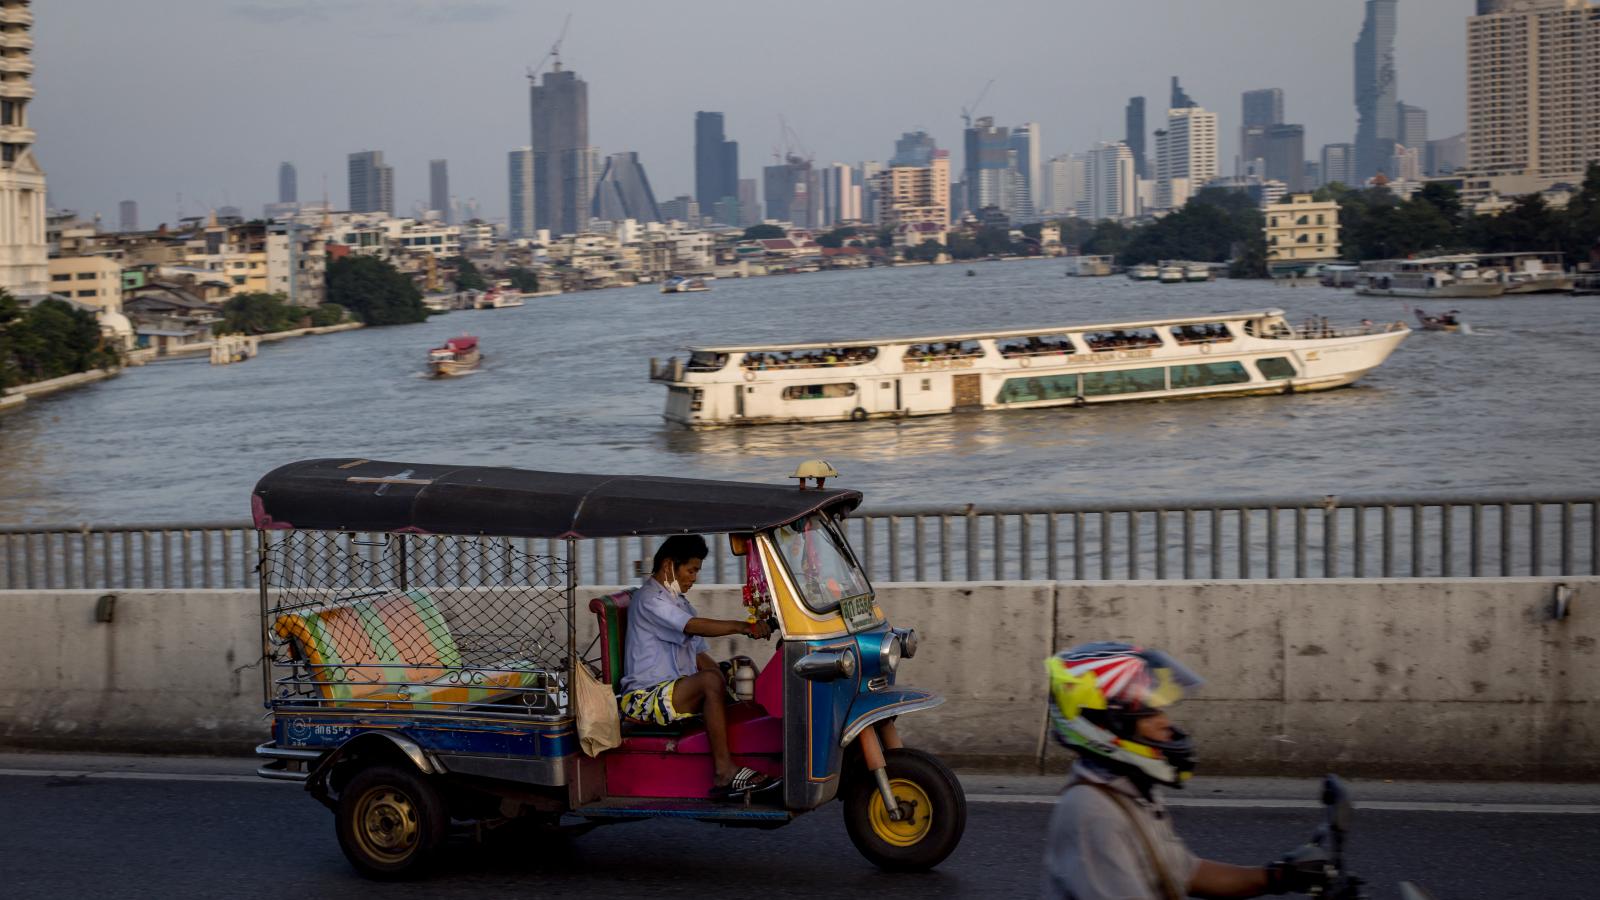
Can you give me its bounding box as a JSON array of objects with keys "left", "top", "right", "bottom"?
[{"left": 650, "top": 309, "right": 1411, "bottom": 428}]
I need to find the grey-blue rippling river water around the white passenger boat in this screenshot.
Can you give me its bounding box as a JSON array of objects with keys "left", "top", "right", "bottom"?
[{"left": 0, "top": 261, "right": 1600, "bottom": 525}]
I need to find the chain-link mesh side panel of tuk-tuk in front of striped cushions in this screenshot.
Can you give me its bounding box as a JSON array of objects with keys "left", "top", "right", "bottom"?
[{"left": 261, "top": 532, "right": 570, "bottom": 716}]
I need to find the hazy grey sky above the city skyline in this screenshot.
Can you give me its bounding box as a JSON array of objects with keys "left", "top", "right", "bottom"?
[{"left": 32, "top": 0, "right": 1472, "bottom": 227}]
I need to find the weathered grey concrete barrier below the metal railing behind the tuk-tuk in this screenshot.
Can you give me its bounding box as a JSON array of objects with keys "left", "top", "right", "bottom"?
[{"left": 0, "top": 577, "right": 1600, "bottom": 780}]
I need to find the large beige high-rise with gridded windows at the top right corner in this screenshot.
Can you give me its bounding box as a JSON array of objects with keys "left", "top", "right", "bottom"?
[{"left": 1467, "top": 0, "right": 1600, "bottom": 195}]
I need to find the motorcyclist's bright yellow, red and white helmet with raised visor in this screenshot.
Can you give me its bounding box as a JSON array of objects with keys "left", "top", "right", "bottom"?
[{"left": 1045, "top": 641, "right": 1200, "bottom": 788}]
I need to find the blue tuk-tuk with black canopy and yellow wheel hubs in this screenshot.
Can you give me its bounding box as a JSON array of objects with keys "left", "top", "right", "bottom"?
[{"left": 251, "top": 460, "right": 966, "bottom": 878}]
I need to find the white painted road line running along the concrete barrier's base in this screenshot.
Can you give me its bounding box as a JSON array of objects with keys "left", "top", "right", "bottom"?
[{"left": 0, "top": 769, "right": 1600, "bottom": 815}]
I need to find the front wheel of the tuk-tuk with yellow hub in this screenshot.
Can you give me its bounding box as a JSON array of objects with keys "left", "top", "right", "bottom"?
[{"left": 842, "top": 748, "right": 966, "bottom": 871}]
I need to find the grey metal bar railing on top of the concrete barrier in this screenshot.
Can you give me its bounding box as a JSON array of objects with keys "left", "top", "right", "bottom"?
[{"left": 0, "top": 492, "right": 1600, "bottom": 589}]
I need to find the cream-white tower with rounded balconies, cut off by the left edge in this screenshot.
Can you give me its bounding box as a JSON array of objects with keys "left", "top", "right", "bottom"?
[{"left": 0, "top": 0, "right": 50, "bottom": 295}]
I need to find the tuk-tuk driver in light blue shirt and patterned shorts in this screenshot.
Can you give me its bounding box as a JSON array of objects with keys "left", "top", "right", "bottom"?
[{"left": 621, "top": 535, "right": 778, "bottom": 799}]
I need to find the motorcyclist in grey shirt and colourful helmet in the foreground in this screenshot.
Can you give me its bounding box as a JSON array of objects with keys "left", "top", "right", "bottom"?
[{"left": 1043, "top": 642, "right": 1328, "bottom": 900}]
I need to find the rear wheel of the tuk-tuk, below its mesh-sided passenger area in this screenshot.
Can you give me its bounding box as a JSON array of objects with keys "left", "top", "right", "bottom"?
[{"left": 334, "top": 765, "right": 448, "bottom": 879}]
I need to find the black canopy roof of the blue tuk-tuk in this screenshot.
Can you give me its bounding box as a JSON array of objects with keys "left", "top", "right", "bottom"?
[{"left": 251, "top": 458, "right": 861, "bottom": 538}]
